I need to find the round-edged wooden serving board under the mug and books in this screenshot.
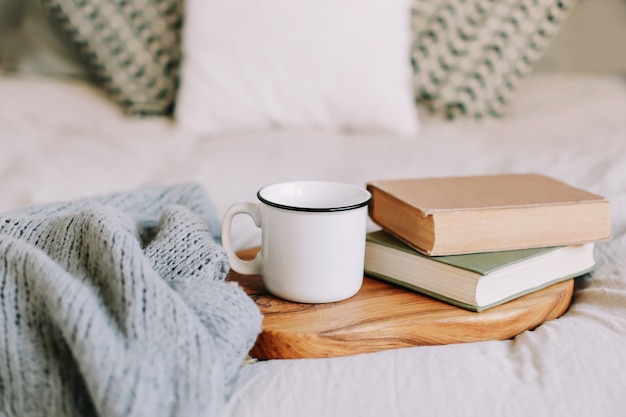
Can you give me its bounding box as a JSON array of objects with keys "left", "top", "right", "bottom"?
[{"left": 227, "top": 249, "right": 574, "bottom": 359}]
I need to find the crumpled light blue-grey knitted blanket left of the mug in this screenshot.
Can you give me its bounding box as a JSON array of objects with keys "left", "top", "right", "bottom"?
[{"left": 0, "top": 184, "right": 261, "bottom": 417}]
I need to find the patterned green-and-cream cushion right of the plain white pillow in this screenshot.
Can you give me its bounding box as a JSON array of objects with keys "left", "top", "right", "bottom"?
[{"left": 412, "top": 0, "right": 576, "bottom": 118}]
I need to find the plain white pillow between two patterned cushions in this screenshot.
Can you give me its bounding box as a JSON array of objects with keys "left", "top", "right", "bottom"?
[{"left": 175, "top": 0, "right": 419, "bottom": 135}]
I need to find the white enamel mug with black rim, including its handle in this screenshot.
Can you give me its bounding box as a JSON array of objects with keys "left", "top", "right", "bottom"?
[{"left": 222, "top": 181, "right": 371, "bottom": 303}]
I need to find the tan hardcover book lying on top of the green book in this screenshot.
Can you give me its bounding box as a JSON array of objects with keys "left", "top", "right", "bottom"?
[{"left": 366, "top": 174, "right": 611, "bottom": 256}]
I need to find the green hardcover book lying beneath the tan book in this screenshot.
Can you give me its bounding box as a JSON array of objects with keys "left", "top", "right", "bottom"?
[{"left": 365, "top": 230, "right": 596, "bottom": 311}]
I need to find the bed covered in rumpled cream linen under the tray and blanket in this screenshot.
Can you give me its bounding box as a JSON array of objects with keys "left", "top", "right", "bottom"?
[{"left": 0, "top": 2, "right": 626, "bottom": 417}]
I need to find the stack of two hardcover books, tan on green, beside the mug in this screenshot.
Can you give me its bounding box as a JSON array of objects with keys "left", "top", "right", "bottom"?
[{"left": 365, "top": 174, "right": 611, "bottom": 311}]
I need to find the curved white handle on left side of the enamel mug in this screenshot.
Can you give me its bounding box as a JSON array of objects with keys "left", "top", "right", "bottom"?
[{"left": 222, "top": 203, "right": 262, "bottom": 275}]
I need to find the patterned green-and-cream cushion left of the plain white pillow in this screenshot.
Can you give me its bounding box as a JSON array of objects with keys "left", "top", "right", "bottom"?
[{"left": 41, "top": 0, "right": 183, "bottom": 115}]
